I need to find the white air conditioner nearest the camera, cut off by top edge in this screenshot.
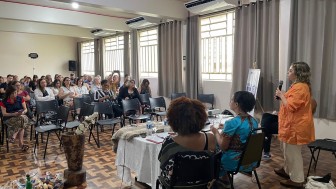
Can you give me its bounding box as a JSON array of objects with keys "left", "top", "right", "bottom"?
[{"left": 184, "top": 0, "right": 238, "bottom": 14}]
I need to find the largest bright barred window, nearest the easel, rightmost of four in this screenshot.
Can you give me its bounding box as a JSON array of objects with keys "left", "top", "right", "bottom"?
[{"left": 201, "top": 12, "right": 235, "bottom": 81}]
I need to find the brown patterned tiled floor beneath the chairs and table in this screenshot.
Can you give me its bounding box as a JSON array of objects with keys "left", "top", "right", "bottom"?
[{"left": 0, "top": 125, "right": 336, "bottom": 189}]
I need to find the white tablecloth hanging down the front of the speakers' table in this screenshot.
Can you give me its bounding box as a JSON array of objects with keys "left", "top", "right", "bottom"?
[{"left": 115, "top": 137, "right": 162, "bottom": 188}]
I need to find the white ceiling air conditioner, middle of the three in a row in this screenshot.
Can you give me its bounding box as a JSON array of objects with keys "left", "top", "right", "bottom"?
[{"left": 126, "top": 16, "right": 162, "bottom": 29}]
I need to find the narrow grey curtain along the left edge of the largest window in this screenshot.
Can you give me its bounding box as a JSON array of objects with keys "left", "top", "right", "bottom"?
[{"left": 185, "top": 16, "right": 202, "bottom": 99}]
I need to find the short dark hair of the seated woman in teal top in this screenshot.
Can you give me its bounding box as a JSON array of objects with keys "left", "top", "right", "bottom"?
[{"left": 233, "top": 91, "right": 256, "bottom": 113}]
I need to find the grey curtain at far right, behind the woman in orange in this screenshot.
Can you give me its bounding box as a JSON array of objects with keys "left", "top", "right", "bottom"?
[{"left": 289, "top": 0, "right": 336, "bottom": 120}]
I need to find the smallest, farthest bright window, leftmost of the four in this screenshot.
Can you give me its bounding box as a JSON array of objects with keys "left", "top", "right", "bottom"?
[{"left": 81, "top": 41, "right": 95, "bottom": 75}]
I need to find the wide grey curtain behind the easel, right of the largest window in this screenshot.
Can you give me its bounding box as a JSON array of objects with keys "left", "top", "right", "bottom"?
[{"left": 231, "top": 0, "right": 279, "bottom": 111}]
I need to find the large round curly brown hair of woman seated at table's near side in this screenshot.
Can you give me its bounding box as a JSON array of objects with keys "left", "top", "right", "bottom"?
[{"left": 167, "top": 97, "right": 207, "bottom": 135}]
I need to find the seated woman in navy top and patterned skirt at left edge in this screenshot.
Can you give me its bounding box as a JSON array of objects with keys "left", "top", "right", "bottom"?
[{"left": 0, "top": 85, "right": 29, "bottom": 151}]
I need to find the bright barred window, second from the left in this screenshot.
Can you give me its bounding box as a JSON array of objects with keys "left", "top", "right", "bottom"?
[{"left": 103, "top": 35, "right": 124, "bottom": 76}]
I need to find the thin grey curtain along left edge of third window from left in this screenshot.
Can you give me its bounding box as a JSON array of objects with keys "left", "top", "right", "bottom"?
[{"left": 129, "top": 30, "right": 139, "bottom": 86}]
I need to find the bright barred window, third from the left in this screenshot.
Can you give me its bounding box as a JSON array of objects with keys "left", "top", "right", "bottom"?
[{"left": 139, "top": 28, "right": 158, "bottom": 77}]
